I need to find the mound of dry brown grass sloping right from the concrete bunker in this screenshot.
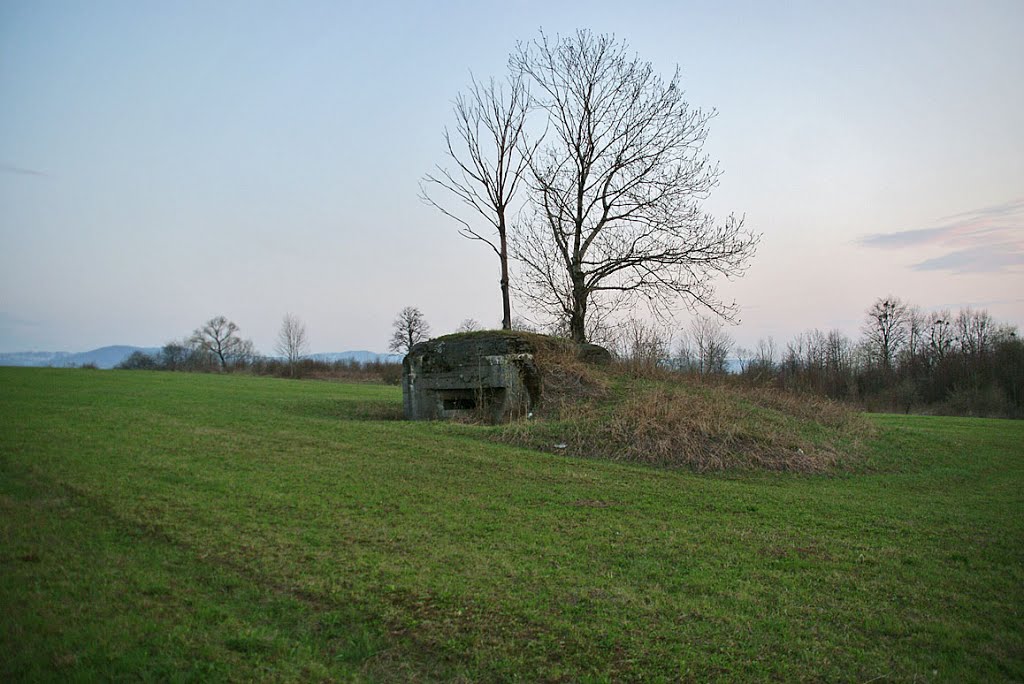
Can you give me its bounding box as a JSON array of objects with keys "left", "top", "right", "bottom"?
[{"left": 500, "top": 360, "right": 870, "bottom": 473}]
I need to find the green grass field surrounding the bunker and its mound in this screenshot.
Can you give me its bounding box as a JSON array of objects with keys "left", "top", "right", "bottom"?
[{"left": 0, "top": 369, "right": 1024, "bottom": 682}]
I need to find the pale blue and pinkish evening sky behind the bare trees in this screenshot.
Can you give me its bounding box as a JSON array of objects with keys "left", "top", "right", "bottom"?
[{"left": 0, "top": 0, "right": 1024, "bottom": 353}]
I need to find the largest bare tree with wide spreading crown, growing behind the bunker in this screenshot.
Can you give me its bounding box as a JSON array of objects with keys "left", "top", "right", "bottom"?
[{"left": 510, "top": 31, "right": 759, "bottom": 342}]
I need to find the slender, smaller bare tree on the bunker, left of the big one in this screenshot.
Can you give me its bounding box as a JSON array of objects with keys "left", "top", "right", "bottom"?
[{"left": 420, "top": 75, "right": 536, "bottom": 330}]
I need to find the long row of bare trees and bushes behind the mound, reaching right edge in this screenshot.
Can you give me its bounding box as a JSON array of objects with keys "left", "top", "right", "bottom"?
[{"left": 610, "top": 296, "right": 1024, "bottom": 418}]
